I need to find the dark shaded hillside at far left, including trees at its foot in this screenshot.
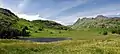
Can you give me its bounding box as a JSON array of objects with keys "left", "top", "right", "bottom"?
[{"left": 0, "top": 8, "right": 27, "bottom": 38}]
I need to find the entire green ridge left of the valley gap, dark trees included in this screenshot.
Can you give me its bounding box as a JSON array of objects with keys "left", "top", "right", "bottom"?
[{"left": 0, "top": 8, "right": 70, "bottom": 38}]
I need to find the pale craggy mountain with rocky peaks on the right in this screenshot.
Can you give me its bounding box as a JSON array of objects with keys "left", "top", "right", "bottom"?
[{"left": 71, "top": 15, "right": 120, "bottom": 34}]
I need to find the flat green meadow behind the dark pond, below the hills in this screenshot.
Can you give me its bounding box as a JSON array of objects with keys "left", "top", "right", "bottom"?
[{"left": 30, "top": 29, "right": 119, "bottom": 40}]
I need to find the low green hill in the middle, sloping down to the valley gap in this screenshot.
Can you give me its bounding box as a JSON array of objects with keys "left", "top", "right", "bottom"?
[{"left": 31, "top": 20, "right": 70, "bottom": 30}]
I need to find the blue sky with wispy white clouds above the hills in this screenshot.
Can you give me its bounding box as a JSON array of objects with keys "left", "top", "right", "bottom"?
[{"left": 0, "top": 0, "right": 120, "bottom": 25}]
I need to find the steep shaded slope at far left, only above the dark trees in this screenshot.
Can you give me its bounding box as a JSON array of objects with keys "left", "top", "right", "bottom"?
[{"left": 0, "top": 8, "right": 18, "bottom": 27}]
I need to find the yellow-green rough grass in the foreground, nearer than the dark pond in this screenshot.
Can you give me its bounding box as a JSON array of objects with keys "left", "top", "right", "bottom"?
[{"left": 0, "top": 37, "right": 120, "bottom": 54}]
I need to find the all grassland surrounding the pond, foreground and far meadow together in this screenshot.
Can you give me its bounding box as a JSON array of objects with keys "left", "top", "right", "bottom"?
[{"left": 0, "top": 30, "right": 120, "bottom": 54}]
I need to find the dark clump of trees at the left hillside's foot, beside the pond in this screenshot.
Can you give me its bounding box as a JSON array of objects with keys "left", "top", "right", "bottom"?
[{"left": 0, "top": 26, "right": 30, "bottom": 39}]
